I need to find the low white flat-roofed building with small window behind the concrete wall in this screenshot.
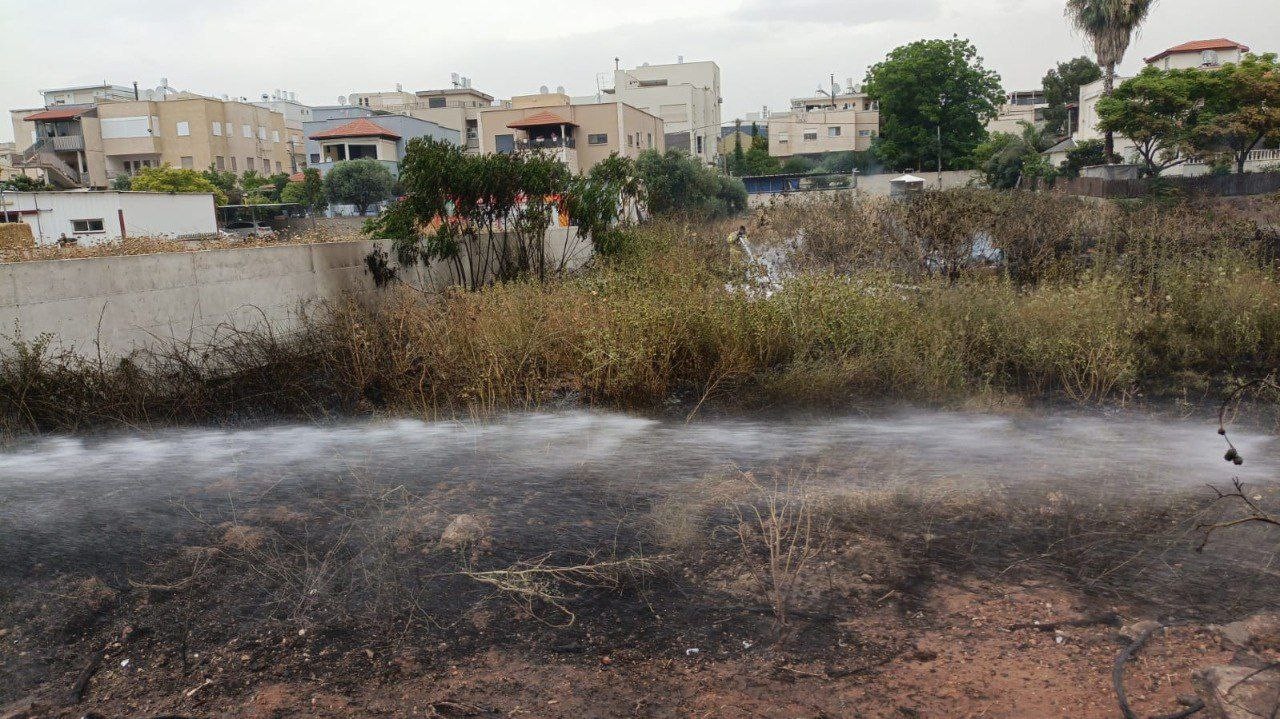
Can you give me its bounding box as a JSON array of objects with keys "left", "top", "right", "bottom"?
[{"left": 0, "top": 191, "right": 218, "bottom": 244}]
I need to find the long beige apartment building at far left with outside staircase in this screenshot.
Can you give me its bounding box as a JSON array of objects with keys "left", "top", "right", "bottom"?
[{"left": 10, "top": 92, "right": 295, "bottom": 188}]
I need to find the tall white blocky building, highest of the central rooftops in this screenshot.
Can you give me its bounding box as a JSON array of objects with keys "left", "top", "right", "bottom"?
[{"left": 588, "top": 58, "right": 723, "bottom": 164}]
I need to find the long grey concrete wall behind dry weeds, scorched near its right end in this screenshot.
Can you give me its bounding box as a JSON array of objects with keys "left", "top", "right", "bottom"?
[{"left": 0, "top": 228, "right": 590, "bottom": 358}]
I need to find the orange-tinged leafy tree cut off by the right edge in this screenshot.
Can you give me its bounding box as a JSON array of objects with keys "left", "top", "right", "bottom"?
[{"left": 1192, "top": 54, "right": 1280, "bottom": 173}]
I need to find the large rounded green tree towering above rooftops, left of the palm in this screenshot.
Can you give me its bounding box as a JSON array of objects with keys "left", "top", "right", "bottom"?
[{"left": 864, "top": 37, "right": 1005, "bottom": 169}]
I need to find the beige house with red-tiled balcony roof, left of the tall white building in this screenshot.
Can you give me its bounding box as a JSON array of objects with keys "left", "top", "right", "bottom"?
[{"left": 477, "top": 92, "right": 666, "bottom": 173}]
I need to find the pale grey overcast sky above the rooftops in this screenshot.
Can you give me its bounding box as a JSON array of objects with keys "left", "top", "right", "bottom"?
[{"left": 0, "top": 0, "right": 1280, "bottom": 139}]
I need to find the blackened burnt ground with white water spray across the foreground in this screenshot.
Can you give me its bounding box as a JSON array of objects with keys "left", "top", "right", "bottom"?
[{"left": 0, "top": 409, "right": 1280, "bottom": 716}]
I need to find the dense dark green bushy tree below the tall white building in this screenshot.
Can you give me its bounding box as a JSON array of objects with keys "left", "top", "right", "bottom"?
[{"left": 636, "top": 148, "right": 747, "bottom": 217}]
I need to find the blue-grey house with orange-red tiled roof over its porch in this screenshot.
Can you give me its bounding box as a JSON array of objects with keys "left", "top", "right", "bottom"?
[{"left": 303, "top": 114, "right": 461, "bottom": 175}]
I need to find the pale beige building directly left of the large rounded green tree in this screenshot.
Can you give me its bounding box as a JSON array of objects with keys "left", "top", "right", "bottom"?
[{"left": 768, "top": 81, "right": 879, "bottom": 157}]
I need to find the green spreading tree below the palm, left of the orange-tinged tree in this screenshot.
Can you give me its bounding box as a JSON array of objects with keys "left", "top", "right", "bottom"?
[{"left": 1098, "top": 67, "right": 1203, "bottom": 177}]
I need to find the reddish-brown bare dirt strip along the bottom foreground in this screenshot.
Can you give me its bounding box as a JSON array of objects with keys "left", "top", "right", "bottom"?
[{"left": 0, "top": 580, "right": 1231, "bottom": 719}]
